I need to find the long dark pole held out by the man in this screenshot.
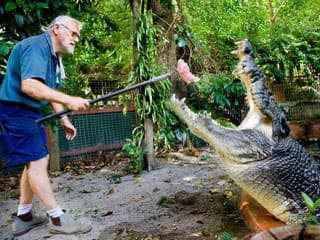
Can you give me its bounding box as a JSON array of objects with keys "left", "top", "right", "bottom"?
[{"left": 36, "top": 73, "right": 171, "bottom": 123}]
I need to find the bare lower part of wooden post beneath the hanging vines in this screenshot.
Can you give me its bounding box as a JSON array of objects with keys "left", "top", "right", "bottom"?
[{"left": 144, "top": 118, "right": 156, "bottom": 171}]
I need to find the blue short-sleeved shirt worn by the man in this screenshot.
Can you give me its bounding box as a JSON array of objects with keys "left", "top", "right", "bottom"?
[{"left": 0, "top": 33, "right": 61, "bottom": 108}]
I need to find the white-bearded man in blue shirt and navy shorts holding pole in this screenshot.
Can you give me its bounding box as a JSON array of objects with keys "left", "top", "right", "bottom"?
[{"left": 0, "top": 16, "right": 91, "bottom": 236}]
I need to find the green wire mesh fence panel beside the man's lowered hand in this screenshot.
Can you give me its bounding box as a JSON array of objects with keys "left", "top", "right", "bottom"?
[{"left": 58, "top": 107, "right": 136, "bottom": 160}]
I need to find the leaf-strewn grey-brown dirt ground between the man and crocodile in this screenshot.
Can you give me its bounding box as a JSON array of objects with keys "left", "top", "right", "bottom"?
[{"left": 0, "top": 148, "right": 250, "bottom": 240}]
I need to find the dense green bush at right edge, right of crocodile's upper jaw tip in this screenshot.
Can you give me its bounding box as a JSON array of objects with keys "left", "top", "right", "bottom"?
[{"left": 256, "top": 31, "right": 320, "bottom": 82}]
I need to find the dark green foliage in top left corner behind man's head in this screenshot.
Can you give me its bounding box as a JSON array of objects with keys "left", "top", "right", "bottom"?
[{"left": 0, "top": 0, "right": 96, "bottom": 78}]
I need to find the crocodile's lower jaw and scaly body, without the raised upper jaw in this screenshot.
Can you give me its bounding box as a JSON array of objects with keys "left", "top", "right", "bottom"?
[{"left": 171, "top": 96, "right": 320, "bottom": 223}]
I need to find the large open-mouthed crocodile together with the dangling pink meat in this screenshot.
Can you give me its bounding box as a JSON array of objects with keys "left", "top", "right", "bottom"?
[{"left": 170, "top": 39, "right": 320, "bottom": 224}]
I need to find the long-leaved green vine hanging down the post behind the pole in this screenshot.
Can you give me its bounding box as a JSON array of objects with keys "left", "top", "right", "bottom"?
[{"left": 124, "top": 12, "right": 176, "bottom": 173}]
